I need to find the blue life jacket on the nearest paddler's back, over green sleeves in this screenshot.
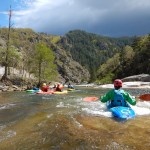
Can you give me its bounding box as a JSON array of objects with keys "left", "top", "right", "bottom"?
[{"left": 111, "top": 89, "right": 127, "bottom": 107}]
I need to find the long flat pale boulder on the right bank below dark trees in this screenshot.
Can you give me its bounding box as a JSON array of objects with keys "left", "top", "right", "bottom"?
[{"left": 122, "top": 74, "right": 150, "bottom": 82}]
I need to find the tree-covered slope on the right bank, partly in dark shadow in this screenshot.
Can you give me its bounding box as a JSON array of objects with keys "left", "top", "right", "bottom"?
[{"left": 97, "top": 35, "right": 150, "bottom": 82}]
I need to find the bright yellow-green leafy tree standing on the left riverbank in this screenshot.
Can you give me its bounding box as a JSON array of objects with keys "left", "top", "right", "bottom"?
[{"left": 32, "top": 43, "right": 58, "bottom": 83}]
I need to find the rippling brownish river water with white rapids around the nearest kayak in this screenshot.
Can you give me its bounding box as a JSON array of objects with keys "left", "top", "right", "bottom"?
[{"left": 0, "top": 87, "right": 150, "bottom": 150}]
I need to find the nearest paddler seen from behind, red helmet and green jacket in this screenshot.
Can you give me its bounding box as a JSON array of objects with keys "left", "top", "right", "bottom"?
[{"left": 100, "top": 79, "right": 136, "bottom": 107}]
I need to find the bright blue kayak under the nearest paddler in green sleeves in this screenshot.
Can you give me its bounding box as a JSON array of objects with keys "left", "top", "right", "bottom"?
[{"left": 106, "top": 101, "right": 136, "bottom": 119}]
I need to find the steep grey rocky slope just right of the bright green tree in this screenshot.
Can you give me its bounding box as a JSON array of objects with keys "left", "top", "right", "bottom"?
[{"left": 55, "top": 48, "right": 90, "bottom": 83}]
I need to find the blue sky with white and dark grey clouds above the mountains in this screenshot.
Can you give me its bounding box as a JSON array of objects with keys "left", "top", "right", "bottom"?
[{"left": 0, "top": 0, "right": 150, "bottom": 37}]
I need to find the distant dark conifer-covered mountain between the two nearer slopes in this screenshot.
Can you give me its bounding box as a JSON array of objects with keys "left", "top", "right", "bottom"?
[{"left": 60, "top": 30, "right": 134, "bottom": 80}]
